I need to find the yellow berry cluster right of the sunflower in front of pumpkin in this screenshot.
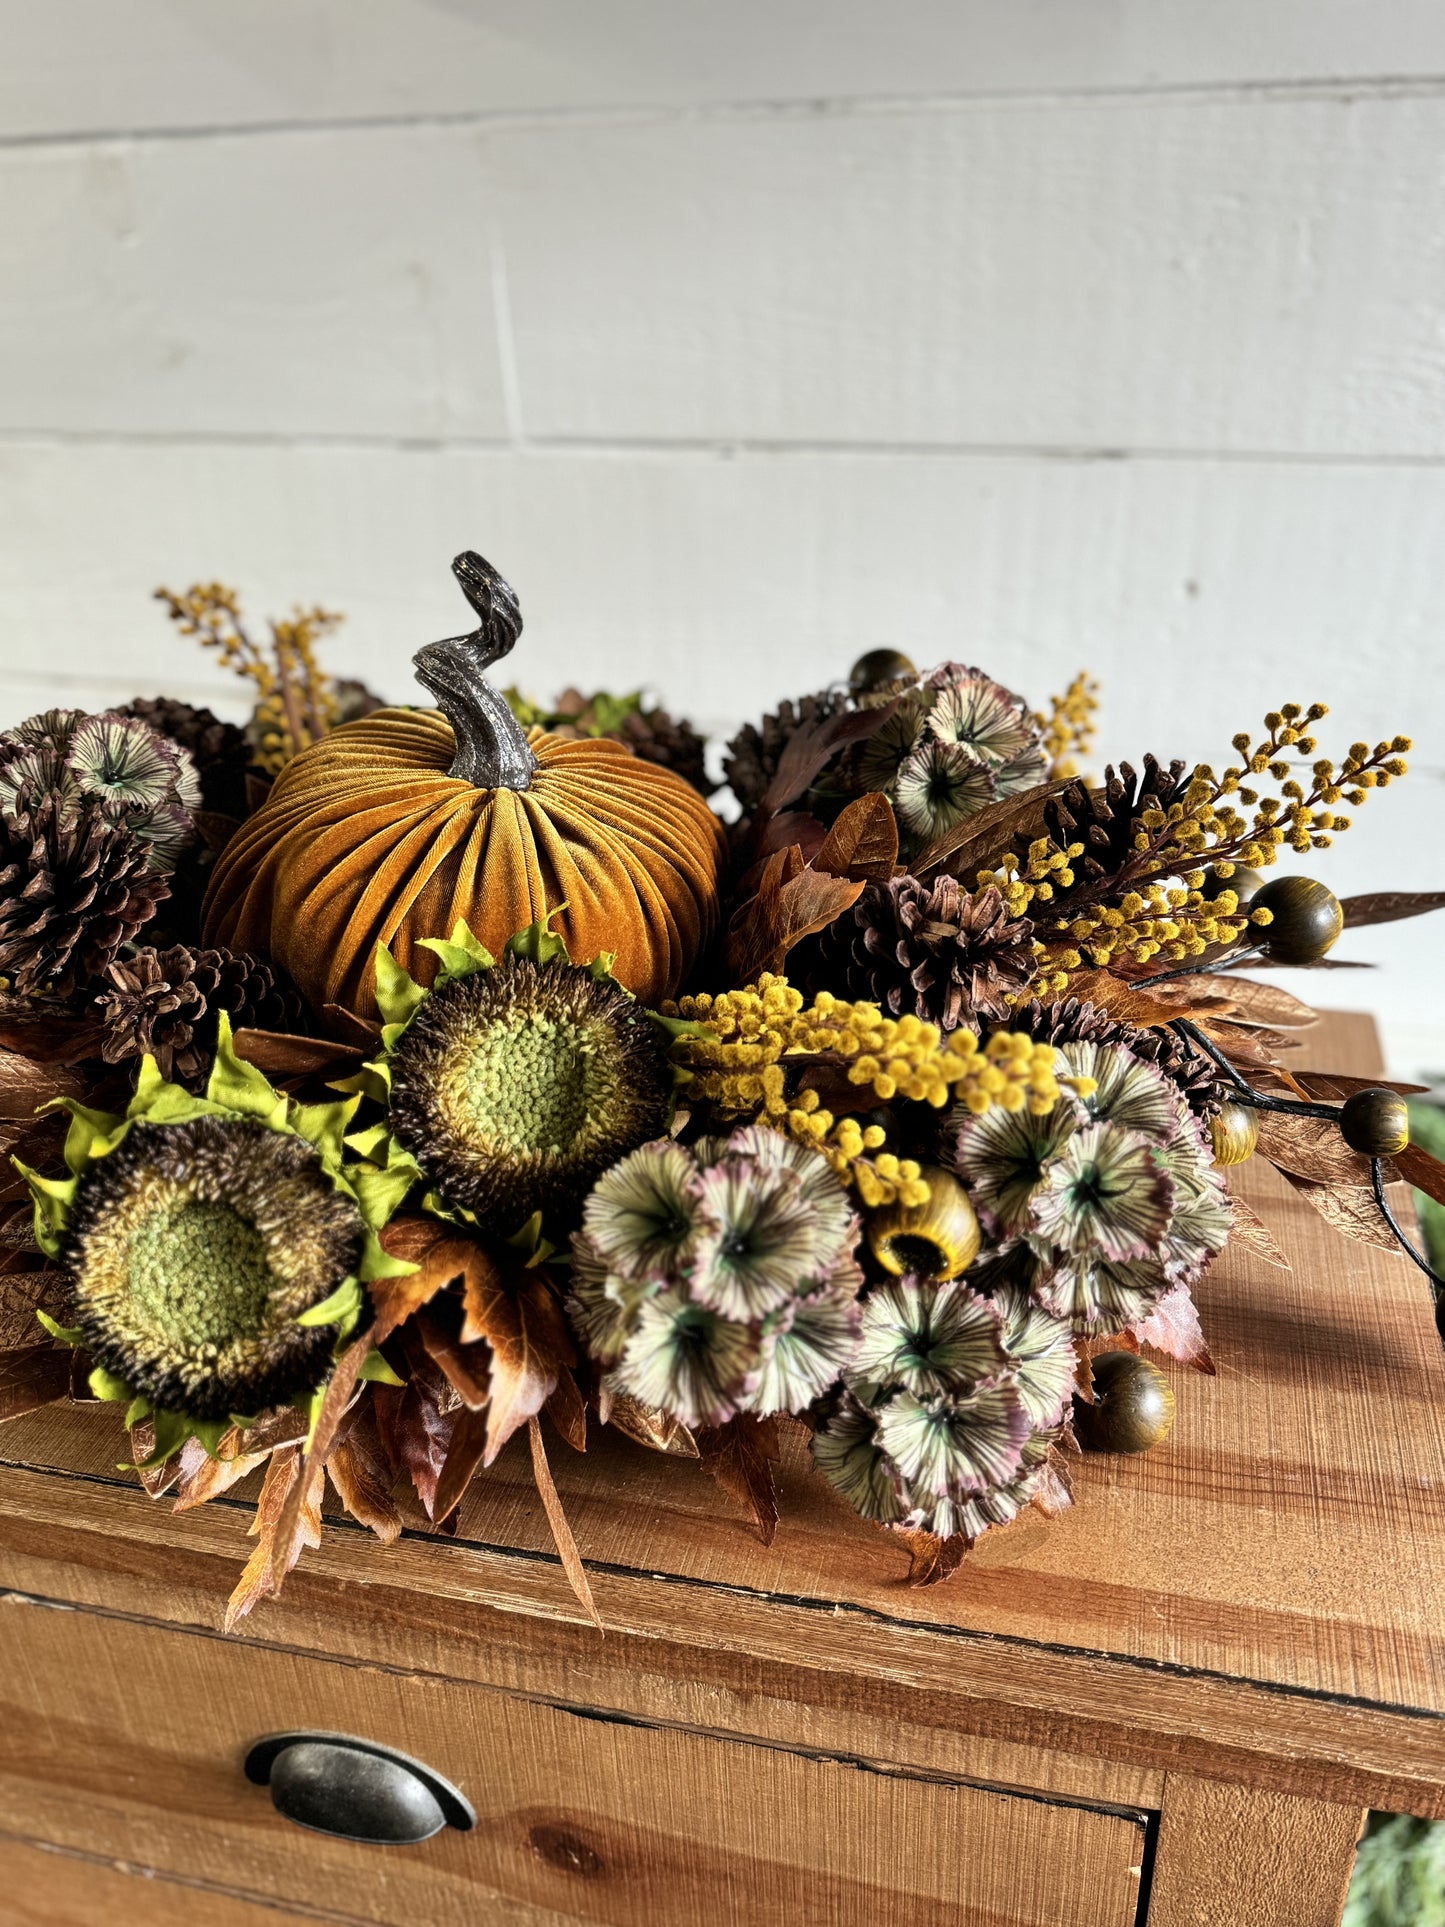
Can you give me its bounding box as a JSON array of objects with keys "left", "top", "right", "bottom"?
[{"left": 665, "top": 973, "right": 1060, "bottom": 1206}]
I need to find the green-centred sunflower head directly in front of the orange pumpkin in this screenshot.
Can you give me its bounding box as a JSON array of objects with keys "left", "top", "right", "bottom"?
[{"left": 355, "top": 919, "right": 676, "bottom": 1231}]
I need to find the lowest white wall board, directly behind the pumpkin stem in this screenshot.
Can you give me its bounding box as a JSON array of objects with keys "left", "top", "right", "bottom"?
[{"left": 0, "top": 443, "right": 1445, "bottom": 1073}]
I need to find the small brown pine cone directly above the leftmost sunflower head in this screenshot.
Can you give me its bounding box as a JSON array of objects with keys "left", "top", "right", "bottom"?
[{"left": 98, "top": 944, "right": 304, "bottom": 1089}]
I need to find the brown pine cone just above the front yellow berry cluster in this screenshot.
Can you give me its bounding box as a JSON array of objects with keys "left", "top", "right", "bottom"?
[{"left": 805, "top": 877, "right": 1037, "bottom": 1031}]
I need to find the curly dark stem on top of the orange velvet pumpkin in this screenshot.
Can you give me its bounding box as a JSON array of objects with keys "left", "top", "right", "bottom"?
[{"left": 412, "top": 549, "right": 538, "bottom": 790}]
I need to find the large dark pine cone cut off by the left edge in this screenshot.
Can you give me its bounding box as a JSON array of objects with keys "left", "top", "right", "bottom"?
[{"left": 0, "top": 796, "right": 170, "bottom": 996}]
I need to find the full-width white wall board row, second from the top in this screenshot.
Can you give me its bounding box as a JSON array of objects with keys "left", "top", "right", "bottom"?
[{"left": 0, "top": 98, "right": 1445, "bottom": 459}]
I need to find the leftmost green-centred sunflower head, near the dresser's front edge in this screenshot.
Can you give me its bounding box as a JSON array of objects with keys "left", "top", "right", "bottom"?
[{"left": 21, "top": 1016, "right": 408, "bottom": 1457}]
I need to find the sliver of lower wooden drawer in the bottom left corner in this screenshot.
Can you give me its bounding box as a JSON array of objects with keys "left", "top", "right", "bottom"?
[{"left": 0, "top": 1835, "right": 344, "bottom": 1927}]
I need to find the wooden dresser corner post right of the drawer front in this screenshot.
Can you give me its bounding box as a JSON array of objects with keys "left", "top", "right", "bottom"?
[{"left": 1148, "top": 1775, "right": 1364, "bottom": 1927}]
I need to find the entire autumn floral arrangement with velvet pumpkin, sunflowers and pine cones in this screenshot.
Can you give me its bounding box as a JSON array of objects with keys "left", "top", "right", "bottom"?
[{"left": 0, "top": 553, "right": 1445, "bottom": 1621}]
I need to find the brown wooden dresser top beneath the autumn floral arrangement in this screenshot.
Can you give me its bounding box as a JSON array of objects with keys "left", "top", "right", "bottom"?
[{"left": 0, "top": 1019, "right": 1445, "bottom": 1813}]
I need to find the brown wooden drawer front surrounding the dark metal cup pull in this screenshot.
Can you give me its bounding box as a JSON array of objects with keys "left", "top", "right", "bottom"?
[{"left": 0, "top": 1596, "right": 1144, "bottom": 1927}]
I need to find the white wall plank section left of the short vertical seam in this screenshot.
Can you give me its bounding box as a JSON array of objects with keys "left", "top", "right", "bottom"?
[{"left": 0, "top": 129, "right": 505, "bottom": 437}]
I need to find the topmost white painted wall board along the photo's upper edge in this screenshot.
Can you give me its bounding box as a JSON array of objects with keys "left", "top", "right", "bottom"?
[{"left": 0, "top": 0, "right": 1445, "bottom": 135}]
